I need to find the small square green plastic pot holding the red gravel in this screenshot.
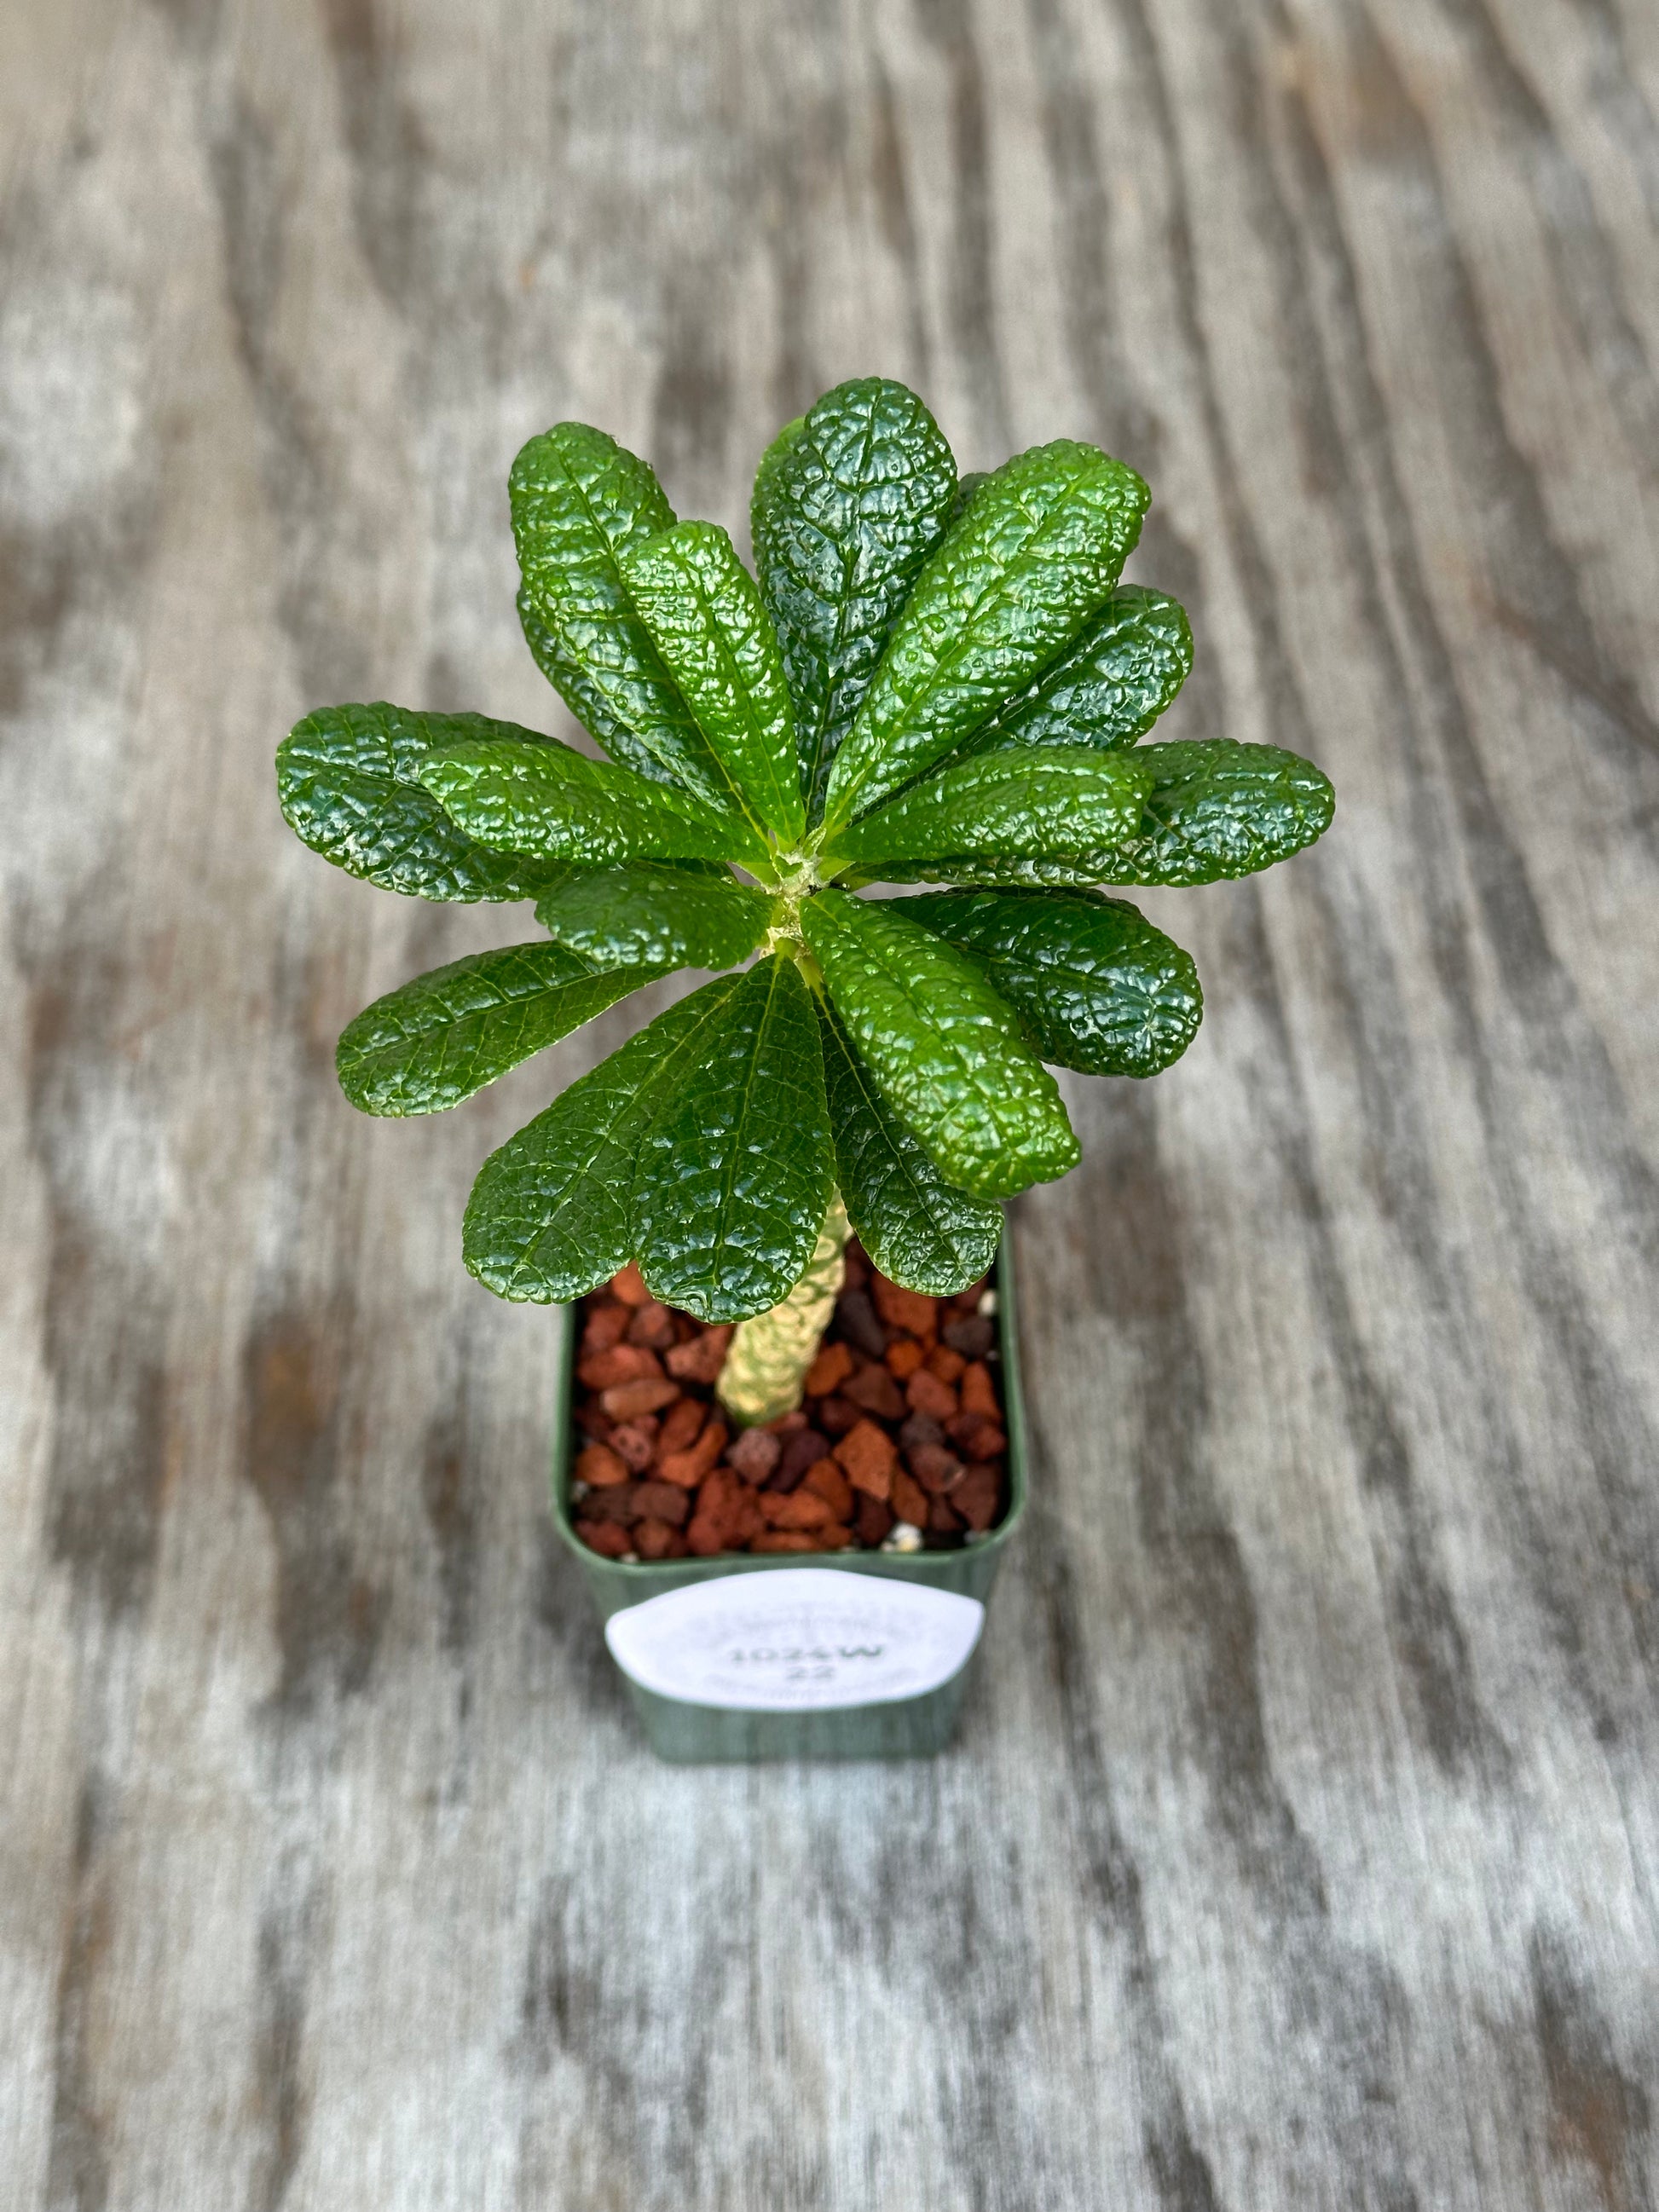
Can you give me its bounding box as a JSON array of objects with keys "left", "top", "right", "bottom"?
[{"left": 553, "top": 1234, "right": 1026, "bottom": 1765}]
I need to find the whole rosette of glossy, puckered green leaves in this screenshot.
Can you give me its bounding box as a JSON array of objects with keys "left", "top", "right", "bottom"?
[{"left": 279, "top": 378, "right": 1332, "bottom": 1320}]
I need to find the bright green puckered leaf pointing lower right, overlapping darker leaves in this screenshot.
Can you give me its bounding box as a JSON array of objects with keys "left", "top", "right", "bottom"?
[{"left": 801, "top": 892, "right": 1078, "bottom": 1198}]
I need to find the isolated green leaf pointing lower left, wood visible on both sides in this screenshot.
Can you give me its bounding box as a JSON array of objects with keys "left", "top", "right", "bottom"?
[{"left": 334, "top": 944, "right": 668, "bottom": 1115}]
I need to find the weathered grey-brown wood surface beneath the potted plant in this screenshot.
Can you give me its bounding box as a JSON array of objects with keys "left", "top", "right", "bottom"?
[{"left": 0, "top": 0, "right": 1659, "bottom": 2212}]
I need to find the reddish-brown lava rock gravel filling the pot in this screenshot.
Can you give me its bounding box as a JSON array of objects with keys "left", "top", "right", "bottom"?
[{"left": 570, "top": 1243, "right": 1009, "bottom": 1562}]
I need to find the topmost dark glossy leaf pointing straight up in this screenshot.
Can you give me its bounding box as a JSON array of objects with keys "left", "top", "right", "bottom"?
[{"left": 750, "top": 376, "right": 956, "bottom": 814}]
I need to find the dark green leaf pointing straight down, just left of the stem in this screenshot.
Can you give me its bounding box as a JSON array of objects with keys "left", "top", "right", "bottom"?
[{"left": 635, "top": 953, "right": 834, "bottom": 1320}]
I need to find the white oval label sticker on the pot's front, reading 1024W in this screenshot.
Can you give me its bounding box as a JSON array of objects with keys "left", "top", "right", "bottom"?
[{"left": 604, "top": 1566, "right": 985, "bottom": 1712}]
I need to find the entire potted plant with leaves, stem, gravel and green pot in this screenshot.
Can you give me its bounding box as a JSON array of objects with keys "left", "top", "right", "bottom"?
[{"left": 279, "top": 378, "right": 1334, "bottom": 1756}]
